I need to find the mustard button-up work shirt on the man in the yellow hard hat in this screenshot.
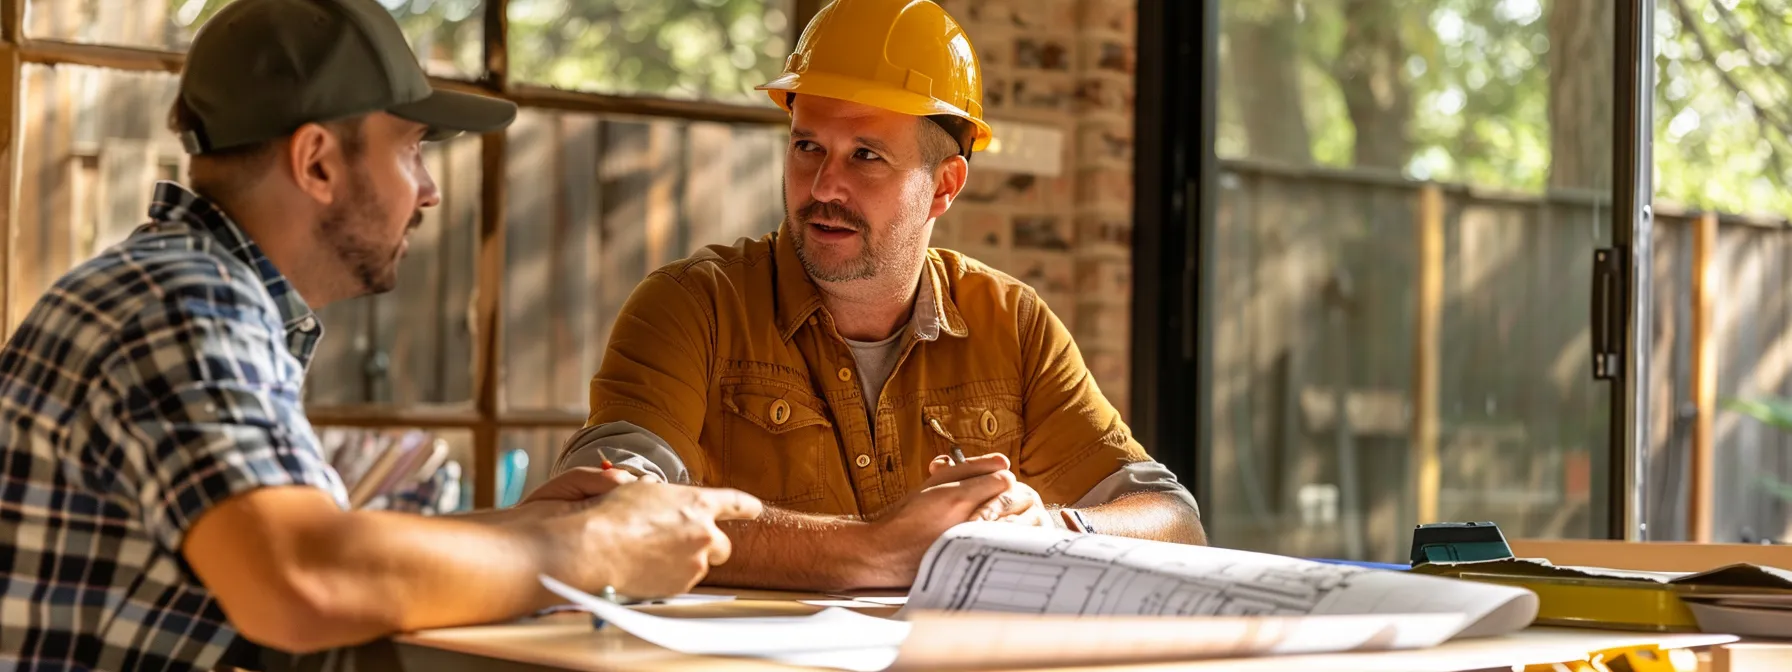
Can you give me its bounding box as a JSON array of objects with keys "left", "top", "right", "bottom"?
[{"left": 556, "top": 226, "right": 1195, "bottom": 516}]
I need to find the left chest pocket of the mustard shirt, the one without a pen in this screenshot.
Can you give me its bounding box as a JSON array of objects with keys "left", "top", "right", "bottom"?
[{"left": 722, "top": 383, "right": 839, "bottom": 505}]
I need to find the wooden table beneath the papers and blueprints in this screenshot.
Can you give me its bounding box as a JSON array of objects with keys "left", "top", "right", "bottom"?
[{"left": 391, "top": 591, "right": 1735, "bottom": 672}]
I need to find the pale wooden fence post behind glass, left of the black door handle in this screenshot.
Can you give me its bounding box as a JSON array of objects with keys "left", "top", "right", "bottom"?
[{"left": 1412, "top": 183, "right": 1444, "bottom": 523}]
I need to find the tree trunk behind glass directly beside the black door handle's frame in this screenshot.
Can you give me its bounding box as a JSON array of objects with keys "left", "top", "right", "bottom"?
[{"left": 1548, "top": 0, "right": 1615, "bottom": 190}]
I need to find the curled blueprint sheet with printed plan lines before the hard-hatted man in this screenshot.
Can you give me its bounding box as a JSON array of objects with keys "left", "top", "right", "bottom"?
[{"left": 901, "top": 521, "right": 1538, "bottom": 649}]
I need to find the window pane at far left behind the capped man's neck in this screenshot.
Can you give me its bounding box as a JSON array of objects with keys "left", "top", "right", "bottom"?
[{"left": 9, "top": 65, "right": 186, "bottom": 324}]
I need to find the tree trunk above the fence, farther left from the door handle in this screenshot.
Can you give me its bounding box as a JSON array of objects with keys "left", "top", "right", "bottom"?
[{"left": 1331, "top": 0, "right": 1412, "bottom": 170}]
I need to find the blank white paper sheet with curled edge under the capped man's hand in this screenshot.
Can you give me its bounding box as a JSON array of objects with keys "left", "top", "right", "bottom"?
[{"left": 541, "top": 575, "right": 910, "bottom": 672}]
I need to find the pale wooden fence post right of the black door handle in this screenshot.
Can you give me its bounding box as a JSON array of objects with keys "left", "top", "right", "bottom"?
[{"left": 1686, "top": 211, "right": 1717, "bottom": 543}]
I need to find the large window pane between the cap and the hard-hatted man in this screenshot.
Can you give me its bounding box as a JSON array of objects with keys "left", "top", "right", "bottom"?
[{"left": 502, "top": 109, "right": 787, "bottom": 414}]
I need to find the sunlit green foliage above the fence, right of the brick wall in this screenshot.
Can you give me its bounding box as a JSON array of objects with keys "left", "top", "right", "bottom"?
[{"left": 1219, "top": 0, "right": 1792, "bottom": 217}]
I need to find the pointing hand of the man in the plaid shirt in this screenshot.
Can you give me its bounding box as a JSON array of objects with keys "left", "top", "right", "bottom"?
[{"left": 543, "top": 483, "right": 763, "bottom": 597}]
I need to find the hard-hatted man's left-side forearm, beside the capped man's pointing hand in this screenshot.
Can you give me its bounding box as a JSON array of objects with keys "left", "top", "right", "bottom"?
[{"left": 704, "top": 507, "right": 889, "bottom": 590}]
